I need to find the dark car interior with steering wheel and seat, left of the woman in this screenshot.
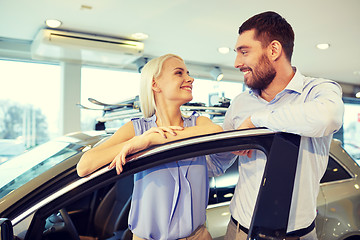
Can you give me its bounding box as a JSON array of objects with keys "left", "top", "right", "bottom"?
[{"left": 42, "top": 175, "right": 134, "bottom": 240}]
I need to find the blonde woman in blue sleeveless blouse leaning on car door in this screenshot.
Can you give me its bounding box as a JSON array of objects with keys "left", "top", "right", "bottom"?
[{"left": 77, "top": 54, "right": 222, "bottom": 239}]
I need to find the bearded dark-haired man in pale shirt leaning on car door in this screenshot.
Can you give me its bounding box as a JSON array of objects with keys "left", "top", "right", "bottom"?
[{"left": 223, "top": 12, "right": 343, "bottom": 240}]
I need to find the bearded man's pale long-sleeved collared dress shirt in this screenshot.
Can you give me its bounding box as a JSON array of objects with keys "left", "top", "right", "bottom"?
[{"left": 222, "top": 68, "right": 344, "bottom": 232}]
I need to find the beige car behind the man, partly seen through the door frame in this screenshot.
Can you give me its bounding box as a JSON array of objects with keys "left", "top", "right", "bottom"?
[{"left": 207, "top": 139, "right": 360, "bottom": 240}]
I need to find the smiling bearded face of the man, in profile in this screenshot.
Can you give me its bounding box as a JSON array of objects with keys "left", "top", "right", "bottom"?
[{"left": 235, "top": 30, "right": 276, "bottom": 90}]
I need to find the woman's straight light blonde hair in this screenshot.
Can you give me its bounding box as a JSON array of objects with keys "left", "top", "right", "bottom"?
[{"left": 139, "top": 54, "right": 184, "bottom": 118}]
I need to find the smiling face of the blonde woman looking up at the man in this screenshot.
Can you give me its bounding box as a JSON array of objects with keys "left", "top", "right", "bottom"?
[{"left": 153, "top": 57, "right": 194, "bottom": 105}]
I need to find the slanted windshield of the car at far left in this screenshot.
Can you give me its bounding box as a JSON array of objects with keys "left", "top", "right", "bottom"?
[{"left": 0, "top": 141, "right": 82, "bottom": 199}]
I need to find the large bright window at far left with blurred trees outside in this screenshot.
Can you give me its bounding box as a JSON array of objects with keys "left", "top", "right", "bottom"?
[{"left": 0, "top": 59, "right": 60, "bottom": 164}]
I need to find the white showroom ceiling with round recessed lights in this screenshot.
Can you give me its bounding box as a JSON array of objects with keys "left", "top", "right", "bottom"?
[{"left": 0, "top": 0, "right": 360, "bottom": 89}]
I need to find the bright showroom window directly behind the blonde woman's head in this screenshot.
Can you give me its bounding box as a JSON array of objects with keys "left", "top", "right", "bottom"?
[{"left": 81, "top": 67, "right": 243, "bottom": 131}]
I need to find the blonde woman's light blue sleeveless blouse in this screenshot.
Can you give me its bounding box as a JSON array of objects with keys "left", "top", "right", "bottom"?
[{"left": 129, "top": 112, "right": 209, "bottom": 240}]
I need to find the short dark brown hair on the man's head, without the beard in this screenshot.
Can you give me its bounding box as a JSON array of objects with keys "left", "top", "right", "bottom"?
[{"left": 239, "top": 11, "right": 295, "bottom": 62}]
